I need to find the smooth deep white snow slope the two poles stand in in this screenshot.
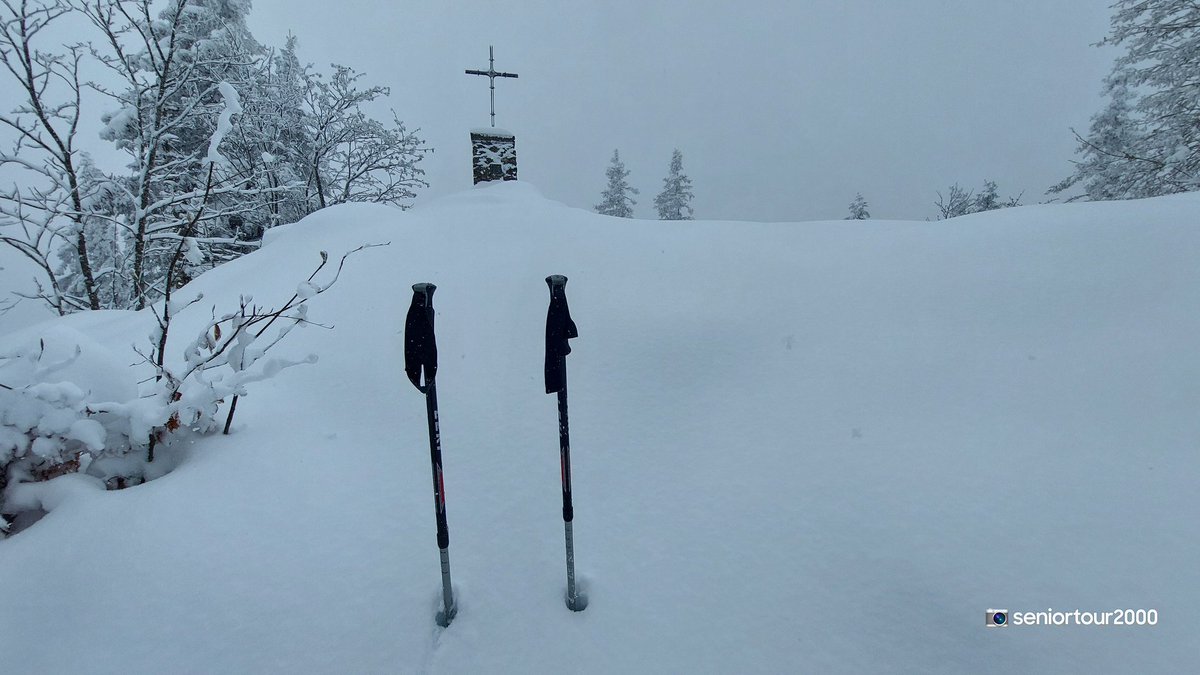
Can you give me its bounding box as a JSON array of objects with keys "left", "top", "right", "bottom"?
[{"left": 0, "top": 183, "right": 1200, "bottom": 674}]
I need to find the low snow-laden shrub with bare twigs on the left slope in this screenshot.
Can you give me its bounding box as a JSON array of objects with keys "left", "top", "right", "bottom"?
[{"left": 0, "top": 246, "right": 368, "bottom": 533}]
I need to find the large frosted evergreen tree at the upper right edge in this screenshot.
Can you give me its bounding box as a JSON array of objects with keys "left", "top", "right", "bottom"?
[{"left": 1050, "top": 0, "right": 1200, "bottom": 199}]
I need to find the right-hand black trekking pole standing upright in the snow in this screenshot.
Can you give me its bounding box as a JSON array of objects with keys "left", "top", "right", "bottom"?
[{"left": 546, "top": 274, "right": 588, "bottom": 611}]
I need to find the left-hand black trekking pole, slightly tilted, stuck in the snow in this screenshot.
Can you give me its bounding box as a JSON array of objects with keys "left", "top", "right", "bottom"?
[{"left": 404, "top": 283, "right": 457, "bottom": 628}]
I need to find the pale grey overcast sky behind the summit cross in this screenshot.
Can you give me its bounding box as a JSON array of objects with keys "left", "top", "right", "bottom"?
[{"left": 14, "top": 0, "right": 1116, "bottom": 221}]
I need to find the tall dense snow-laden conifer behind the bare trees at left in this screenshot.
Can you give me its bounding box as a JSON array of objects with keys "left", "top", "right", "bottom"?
[{"left": 80, "top": 0, "right": 276, "bottom": 309}]
